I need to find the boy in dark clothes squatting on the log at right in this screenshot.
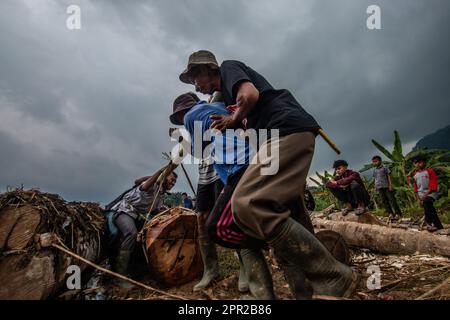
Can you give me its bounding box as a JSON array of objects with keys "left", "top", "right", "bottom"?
[{"left": 326, "top": 160, "right": 370, "bottom": 215}]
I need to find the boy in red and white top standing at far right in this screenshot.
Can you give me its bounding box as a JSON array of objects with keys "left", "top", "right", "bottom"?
[{"left": 413, "top": 155, "right": 444, "bottom": 232}]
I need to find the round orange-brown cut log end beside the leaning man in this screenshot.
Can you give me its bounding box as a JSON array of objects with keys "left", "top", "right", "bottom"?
[{"left": 142, "top": 208, "right": 203, "bottom": 286}]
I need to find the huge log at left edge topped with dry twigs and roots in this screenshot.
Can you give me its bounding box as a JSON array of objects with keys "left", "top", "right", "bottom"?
[{"left": 0, "top": 190, "right": 105, "bottom": 300}]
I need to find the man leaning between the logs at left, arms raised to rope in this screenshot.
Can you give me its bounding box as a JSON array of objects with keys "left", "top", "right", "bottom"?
[{"left": 105, "top": 169, "right": 177, "bottom": 286}]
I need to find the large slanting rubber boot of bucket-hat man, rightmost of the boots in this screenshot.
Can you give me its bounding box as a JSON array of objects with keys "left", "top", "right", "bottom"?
[{"left": 268, "top": 218, "right": 357, "bottom": 297}]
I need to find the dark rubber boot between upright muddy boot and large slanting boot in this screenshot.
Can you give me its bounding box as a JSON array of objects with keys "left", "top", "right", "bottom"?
[{"left": 274, "top": 251, "right": 313, "bottom": 300}]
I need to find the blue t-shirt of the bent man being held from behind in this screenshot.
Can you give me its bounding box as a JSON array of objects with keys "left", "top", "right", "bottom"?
[{"left": 184, "top": 101, "right": 253, "bottom": 184}]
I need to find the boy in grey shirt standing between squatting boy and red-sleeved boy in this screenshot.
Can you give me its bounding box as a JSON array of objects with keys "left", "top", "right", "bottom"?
[{"left": 372, "top": 156, "right": 402, "bottom": 220}]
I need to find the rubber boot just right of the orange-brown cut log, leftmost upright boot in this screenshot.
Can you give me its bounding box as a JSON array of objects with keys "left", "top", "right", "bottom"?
[{"left": 194, "top": 239, "right": 219, "bottom": 292}]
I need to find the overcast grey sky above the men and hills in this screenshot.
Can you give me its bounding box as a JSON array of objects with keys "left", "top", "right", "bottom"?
[{"left": 0, "top": 0, "right": 450, "bottom": 202}]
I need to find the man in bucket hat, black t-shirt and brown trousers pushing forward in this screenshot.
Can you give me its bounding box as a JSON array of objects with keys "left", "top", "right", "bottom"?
[{"left": 180, "top": 50, "right": 358, "bottom": 299}]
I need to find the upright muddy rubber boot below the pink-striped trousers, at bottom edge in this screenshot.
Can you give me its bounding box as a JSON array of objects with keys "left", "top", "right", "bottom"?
[{"left": 240, "top": 249, "right": 275, "bottom": 300}]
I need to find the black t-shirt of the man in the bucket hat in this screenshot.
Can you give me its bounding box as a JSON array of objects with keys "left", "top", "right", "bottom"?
[{"left": 220, "top": 60, "right": 320, "bottom": 136}]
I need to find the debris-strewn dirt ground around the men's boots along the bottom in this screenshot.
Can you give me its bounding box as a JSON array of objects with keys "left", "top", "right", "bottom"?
[{"left": 89, "top": 248, "right": 450, "bottom": 300}]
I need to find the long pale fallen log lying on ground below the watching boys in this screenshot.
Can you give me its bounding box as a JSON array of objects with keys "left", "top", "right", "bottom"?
[{"left": 313, "top": 218, "right": 450, "bottom": 257}]
